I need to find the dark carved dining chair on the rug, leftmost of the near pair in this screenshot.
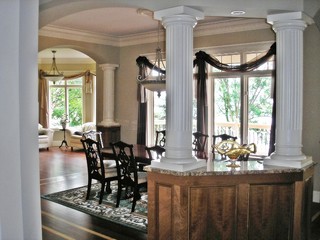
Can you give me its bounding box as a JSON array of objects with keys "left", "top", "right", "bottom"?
[{"left": 80, "top": 138, "right": 118, "bottom": 204}]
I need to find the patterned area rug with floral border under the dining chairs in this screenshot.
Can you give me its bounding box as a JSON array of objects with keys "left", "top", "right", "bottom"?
[{"left": 41, "top": 181, "right": 148, "bottom": 232}]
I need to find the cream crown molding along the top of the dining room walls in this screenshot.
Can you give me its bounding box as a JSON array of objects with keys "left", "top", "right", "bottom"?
[{"left": 39, "top": 18, "right": 271, "bottom": 47}]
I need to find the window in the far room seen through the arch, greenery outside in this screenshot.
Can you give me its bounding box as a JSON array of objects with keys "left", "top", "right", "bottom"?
[{"left": 49, "top": 77, "right": 83, "bottom": 127}]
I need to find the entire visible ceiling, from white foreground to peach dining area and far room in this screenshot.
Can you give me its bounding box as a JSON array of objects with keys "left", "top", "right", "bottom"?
[{"left": 39, "top": 0, "right": 320, "bottom": 62}]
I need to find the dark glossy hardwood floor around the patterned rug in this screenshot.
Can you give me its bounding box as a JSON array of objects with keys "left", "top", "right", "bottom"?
[{"left": 39, "top": 147, "right": 147, "bottom": 240}]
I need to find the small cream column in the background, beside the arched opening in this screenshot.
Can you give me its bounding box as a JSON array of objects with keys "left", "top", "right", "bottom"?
[{"left": 99, "top": 63, "right": 119, "bottom": 127}]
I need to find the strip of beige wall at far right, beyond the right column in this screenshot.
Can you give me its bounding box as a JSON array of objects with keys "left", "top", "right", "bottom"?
[{"left": 302, "top": 25, "right": 320, "bottom": 192}]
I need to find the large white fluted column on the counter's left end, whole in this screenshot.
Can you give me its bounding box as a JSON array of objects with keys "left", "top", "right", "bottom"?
[{"left": 151, "top": 6, "right": 206, "bottom": 171}]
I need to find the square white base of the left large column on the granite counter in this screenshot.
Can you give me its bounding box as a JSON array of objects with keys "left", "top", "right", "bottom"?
[{"left": 151, "top": 158, "right": 207, "bottom": 172}]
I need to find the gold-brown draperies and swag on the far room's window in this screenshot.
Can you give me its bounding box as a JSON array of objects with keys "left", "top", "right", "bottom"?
[{"left": 38, "top": 69, "right": 94, "bottom": 127}]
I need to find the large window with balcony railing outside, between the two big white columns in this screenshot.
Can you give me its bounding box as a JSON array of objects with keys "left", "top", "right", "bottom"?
[{"left": 208, "top": 48, "right": 274, "bottom": 155}]
